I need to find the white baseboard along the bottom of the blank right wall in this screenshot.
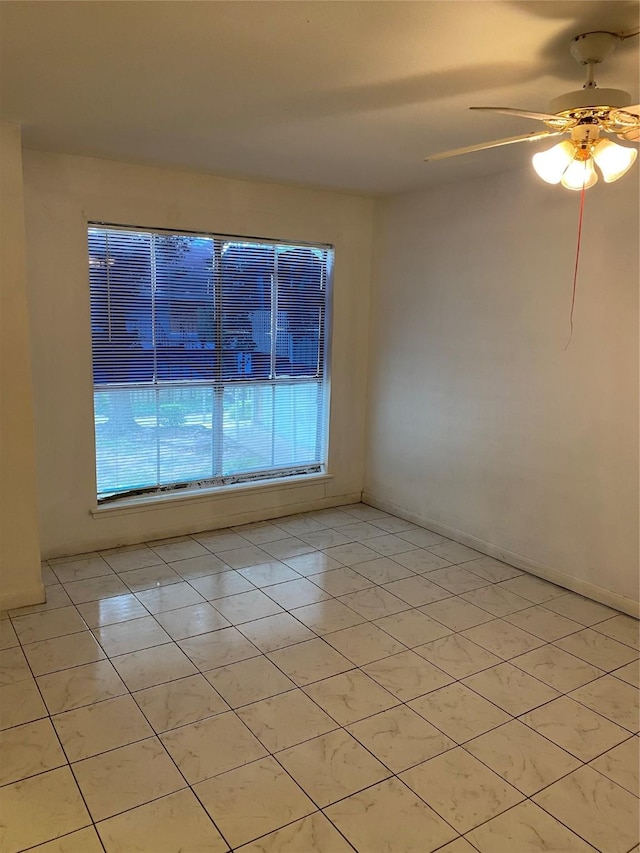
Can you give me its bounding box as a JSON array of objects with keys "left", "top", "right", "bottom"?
[{"left": 362, "top": 492, "right": 640, "bottom": 619}]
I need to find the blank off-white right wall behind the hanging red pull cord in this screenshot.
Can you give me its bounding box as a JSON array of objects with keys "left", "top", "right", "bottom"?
[{"left": 364, "top": 163, "right": 639, "bottom": 612}]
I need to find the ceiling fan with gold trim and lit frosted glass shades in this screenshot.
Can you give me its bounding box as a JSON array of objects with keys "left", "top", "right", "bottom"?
[{"left": 425, "top": 31, "right": 640, "bottom": 190}]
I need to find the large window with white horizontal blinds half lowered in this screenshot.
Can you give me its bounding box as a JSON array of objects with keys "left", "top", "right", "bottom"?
[{"left": 88, "top": 224, "right": 333, "bottom": 502}]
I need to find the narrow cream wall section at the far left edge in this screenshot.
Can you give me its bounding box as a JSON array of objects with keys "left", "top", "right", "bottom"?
[{"left": 0, "top": 122, "right": 44, "bottom": 610}]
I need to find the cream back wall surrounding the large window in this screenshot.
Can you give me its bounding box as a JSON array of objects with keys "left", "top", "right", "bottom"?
[{"left": 24, "top": 151, "right": 373, "bottom": 557}]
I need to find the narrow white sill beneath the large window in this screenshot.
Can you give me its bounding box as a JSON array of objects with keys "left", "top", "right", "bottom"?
[{"left": 90, "top": 474, "right": 333, "bottom": 518}]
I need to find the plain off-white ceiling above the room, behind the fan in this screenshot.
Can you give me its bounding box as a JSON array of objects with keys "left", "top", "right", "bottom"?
[{"left": 0, "top": 0, "right": 640, "bottom": 194}]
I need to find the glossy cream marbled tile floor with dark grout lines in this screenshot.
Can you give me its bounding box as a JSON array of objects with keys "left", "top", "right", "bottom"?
[{"left": 0, "top": 504, "right": 640, "bottom": 853}]
